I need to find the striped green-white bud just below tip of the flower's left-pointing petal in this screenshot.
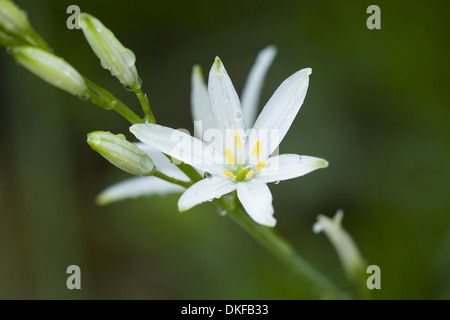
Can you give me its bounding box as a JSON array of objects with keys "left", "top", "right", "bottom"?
[{"left": 87, "top": 131, "right": 156, "bottom": 176}]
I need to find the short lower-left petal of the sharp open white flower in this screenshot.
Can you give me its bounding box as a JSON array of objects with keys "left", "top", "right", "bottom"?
[{"left": 178, "top": 176, "right": 236, "bottom": 212}]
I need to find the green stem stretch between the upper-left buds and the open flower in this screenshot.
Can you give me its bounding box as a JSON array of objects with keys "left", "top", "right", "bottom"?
[{"left": 84, "top": 77, "right": 144, "bottom": 124}]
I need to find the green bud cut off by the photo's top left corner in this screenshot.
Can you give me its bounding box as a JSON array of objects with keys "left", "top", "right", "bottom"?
[{"left": 0, "top": 0, "right": 31, "bottom": 36}]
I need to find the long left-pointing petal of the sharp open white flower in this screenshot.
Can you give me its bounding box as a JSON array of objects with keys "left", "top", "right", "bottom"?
[{"left": 130, "top": 123, "right": 226, "bottom": 175}]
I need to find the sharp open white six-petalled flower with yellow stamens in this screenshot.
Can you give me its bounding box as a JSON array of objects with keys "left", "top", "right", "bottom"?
[{"left": 130, "top": 58, "right": 328, "bottom": 227}]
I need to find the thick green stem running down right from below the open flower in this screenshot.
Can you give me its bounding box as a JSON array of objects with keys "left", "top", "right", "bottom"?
[{"left": 215, "top": 199, "right": 349, "bottom": 299}]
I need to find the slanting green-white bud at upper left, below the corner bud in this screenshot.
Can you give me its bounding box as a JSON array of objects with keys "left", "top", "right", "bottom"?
[{"left": 11, "top": 46, "right": 87, "bottom": 97}]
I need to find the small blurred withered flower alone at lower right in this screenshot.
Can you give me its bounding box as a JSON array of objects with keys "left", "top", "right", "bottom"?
[{"left": 313, "top": 210, "right": 365, "bottom": 281}]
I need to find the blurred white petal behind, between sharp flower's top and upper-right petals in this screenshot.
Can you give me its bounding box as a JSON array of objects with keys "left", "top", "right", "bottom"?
[{"left": 241, "top": 46, "right": 277, "bottom": 128}]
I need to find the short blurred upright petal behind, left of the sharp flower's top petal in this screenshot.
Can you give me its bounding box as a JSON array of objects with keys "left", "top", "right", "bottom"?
[{"left": 191, "top": 66, "right": 216, "bottom": 139}]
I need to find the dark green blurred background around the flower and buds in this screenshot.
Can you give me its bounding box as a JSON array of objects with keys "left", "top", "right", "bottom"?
[{"left": 0, "top": 0, "right": 450, "bottom": 299}]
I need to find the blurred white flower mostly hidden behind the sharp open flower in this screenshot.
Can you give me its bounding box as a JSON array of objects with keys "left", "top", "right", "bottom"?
[{"left": 97, "top": 46, "right": 276, "bottom": 205}]
